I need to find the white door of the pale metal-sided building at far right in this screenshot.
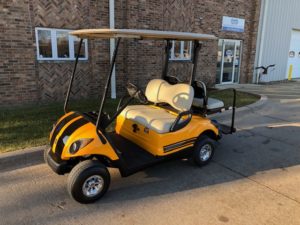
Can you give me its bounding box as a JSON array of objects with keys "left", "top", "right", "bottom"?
[{"left": 287, "top": 30, "right": 300, "bottom": 79}]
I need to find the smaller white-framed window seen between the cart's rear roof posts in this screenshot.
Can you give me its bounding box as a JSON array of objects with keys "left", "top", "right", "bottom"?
[{"left": 170, "top": 41, "right": 192, "bottom": 61}]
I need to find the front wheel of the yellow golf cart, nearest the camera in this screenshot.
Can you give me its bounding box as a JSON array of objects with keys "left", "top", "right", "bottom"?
[{"left": 68, "top": 160, "right": 110, "bottom": 204}]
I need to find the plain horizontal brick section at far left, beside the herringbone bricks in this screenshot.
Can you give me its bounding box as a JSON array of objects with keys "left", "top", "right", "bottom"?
[{"left": 0, "top": 0, "right": 38, "bottom": 105}]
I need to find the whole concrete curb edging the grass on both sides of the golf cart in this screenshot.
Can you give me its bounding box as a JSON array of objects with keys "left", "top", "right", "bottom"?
[{"left": 0, "top": 95, "right": 268, "bottom": 171}]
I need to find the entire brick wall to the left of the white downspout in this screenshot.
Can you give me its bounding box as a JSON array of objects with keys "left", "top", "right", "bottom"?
[{"left": 0, "top": 0, "right": 109, "bottom": 105}]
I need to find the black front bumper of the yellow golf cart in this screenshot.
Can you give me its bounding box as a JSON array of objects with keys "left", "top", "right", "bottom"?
[{"left": 47, "top": 150, "right": 73, "bottom": 175}]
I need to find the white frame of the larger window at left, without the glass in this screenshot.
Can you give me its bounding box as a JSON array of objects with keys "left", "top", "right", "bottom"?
[{"left": 35, "top": 27, "right": 89, "bottom": 61}]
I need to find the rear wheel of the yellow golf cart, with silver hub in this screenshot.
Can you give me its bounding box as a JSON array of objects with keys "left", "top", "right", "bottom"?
[{"left": 193, "top": 135, "right": 215, "bottom": 167}]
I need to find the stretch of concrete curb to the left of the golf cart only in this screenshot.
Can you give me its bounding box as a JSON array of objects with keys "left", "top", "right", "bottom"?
[{"left": 0, "top": 145, "right": 47, "bottom": 171}]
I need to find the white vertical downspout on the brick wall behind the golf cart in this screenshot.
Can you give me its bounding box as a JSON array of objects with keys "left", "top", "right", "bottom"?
[{"left": 109, "top": 0, "right": 117, "bottom": 99}]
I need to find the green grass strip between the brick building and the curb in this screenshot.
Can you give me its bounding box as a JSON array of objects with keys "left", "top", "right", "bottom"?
[{"left": 0, "top": 91, "right": 258, "bottom": 152}]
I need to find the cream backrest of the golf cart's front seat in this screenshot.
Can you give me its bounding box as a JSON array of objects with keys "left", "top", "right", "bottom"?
[{"left": 145, "top": 79, "right": 194, "bottom": 112}]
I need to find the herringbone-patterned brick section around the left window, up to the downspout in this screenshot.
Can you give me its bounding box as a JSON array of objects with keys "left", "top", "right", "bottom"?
[{"left": 30, "top": 0, "right": 109, "bottom": 101}]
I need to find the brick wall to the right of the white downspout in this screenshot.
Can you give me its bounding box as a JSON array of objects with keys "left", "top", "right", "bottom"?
[{"left": 116, "top": 0, "right": 260, "bottom": 89}]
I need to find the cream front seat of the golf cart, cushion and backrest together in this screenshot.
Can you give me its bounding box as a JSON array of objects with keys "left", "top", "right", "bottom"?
[{"left": 120, "top": 79, "right": 194, "bottom": 134}]
